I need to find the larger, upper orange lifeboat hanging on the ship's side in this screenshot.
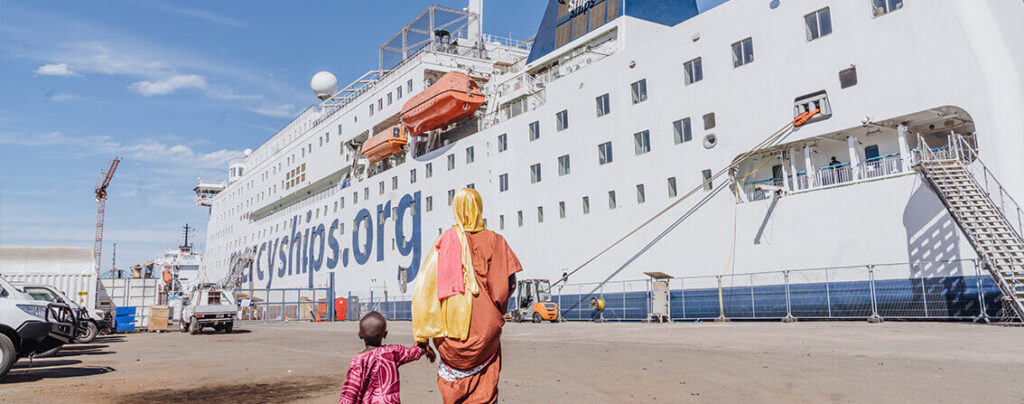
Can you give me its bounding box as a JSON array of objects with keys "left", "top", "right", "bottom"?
[{"left": 401, "top": 72, "right": 483, "bottom": 136}]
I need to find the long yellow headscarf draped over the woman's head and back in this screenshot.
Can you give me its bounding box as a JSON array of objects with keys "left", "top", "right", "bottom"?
[{"left": 413, "top": 188, "right": 483, "bottom": 343}]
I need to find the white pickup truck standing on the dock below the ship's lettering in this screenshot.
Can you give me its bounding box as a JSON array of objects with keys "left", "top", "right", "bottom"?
[{"left": 178, "top": 283, "right": 238, "bottom": 334}]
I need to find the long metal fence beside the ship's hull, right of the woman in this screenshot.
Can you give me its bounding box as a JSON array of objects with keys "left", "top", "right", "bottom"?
[{"left": 552, "top": 260, "right": 1002, "bottom": 321}]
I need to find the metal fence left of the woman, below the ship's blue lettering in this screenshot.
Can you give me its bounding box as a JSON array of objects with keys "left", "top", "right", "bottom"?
[{"left": 236, "top": 273, "right": 335, "bottom": 321}]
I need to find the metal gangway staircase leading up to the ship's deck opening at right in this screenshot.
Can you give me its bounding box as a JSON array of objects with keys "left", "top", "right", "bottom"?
[{"left": 914, "top": 134, "right": 1024, "bottom": 320}]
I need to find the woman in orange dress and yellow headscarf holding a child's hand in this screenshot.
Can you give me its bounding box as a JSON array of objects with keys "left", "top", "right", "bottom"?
[{"left": 413, "top": 188, "right": 522, "bottom": 403}]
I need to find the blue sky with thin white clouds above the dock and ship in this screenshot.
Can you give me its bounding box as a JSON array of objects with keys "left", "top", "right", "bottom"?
[{"left": 0, "top": 0, "right": 547, "bottom": 272}]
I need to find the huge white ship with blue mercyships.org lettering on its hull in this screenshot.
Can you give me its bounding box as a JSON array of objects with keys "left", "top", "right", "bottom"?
[{"left": 197, "top": 0, "right": 1024, "bottom": 319}]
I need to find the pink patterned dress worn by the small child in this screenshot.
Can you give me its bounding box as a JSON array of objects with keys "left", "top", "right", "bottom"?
[{"left": 338, "top": 345, "right": 423, "bottom": 404}]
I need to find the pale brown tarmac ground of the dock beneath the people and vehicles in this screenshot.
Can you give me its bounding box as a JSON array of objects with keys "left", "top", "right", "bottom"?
[{"left": 0, "top": 321, "right": 1024, "bottom": 404}]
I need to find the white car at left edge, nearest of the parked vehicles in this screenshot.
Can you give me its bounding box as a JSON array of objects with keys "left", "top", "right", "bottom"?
[{"left": 0, "top": 277, "right": 76, "bottom": 378}]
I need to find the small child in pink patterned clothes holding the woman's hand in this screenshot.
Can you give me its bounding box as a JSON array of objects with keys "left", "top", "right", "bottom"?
[{"left": 338, "top": 312, "right": 434, "bottom": 404}]
